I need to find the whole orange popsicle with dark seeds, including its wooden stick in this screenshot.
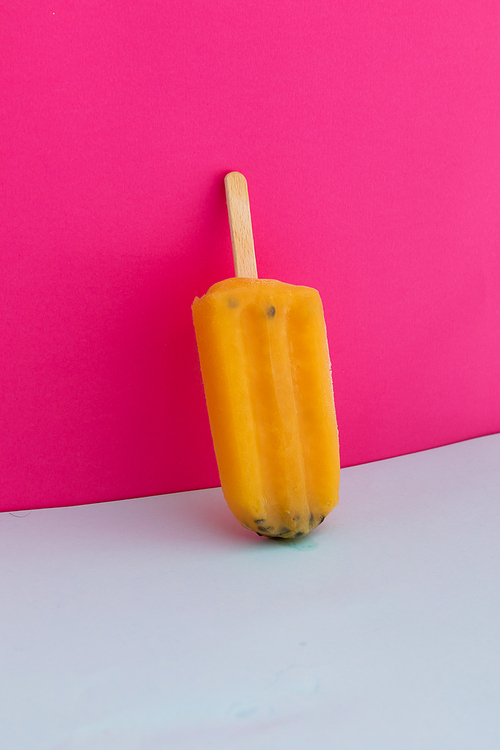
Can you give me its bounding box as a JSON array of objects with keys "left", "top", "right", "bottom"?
[{"left": 192, "top": 172, "right": 340, "bottom": 538}]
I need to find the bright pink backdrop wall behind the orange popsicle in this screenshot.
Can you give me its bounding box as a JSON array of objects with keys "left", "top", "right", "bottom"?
[{"left": 0, "top": 0, "right": 500, "bottom": 510}]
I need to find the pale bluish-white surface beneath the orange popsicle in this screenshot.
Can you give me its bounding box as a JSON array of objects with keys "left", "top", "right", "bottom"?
[{"left": 0, "top": 435, "right": 500, "bottom": 750}]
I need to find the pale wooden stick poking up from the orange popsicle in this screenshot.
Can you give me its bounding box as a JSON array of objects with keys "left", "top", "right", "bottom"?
[{"left": 224, "top": 172, "right": 258, "bottom": 279}]
